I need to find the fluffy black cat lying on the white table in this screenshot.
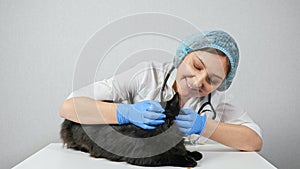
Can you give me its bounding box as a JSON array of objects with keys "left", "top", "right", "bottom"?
[{"left": 60, "top": 94, "right": 202, "bottom": 167}]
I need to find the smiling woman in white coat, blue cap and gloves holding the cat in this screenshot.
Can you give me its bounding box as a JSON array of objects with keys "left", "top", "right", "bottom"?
[{"left": 60, "top": 31, "right": 262, "bottom": 151}]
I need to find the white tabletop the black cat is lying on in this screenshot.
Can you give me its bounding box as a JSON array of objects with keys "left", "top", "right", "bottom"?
[{"left": 13, "top": 143, "right": 276, "bottom": 169}]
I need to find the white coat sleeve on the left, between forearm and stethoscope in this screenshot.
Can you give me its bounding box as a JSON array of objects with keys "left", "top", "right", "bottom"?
[{"left": 68, "top": 63, "right": 147, "bottom": 102}]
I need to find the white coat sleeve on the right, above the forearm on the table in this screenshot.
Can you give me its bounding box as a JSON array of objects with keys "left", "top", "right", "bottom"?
[{"left": 216, "top": 93, "right": 262, "bottom": 137}]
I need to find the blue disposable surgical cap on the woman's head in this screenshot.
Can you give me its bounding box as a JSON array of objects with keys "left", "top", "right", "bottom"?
[{"left": 173, "top": 30, "right": 239, "bottom": 91}]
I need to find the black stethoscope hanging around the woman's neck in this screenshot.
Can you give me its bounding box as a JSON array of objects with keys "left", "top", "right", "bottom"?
[{"left": 160, "top": 66, "right": 217, "bottom": 120}]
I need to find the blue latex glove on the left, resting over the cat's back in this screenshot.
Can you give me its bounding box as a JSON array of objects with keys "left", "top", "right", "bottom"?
[{"left": 117, "top": 100, "right": 166, "bottom": 129}]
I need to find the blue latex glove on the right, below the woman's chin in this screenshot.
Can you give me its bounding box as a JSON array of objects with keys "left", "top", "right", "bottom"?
[{"left": 175, "top": 109, "right": 206, "bottom": 136}]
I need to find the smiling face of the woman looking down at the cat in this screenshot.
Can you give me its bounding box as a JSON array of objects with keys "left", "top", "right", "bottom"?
[{"left": 176, "top": 51, "right": 229, "bottom": 99}]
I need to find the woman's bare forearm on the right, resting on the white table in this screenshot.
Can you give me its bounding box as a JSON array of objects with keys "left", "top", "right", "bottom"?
[{"left": 203, "top": 119, "right": 262, "bottom": 151}]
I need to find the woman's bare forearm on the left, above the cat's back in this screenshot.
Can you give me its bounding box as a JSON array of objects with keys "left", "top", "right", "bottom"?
[{"left": 60, "top": 97, "right": 118, "bottom": 124}]
